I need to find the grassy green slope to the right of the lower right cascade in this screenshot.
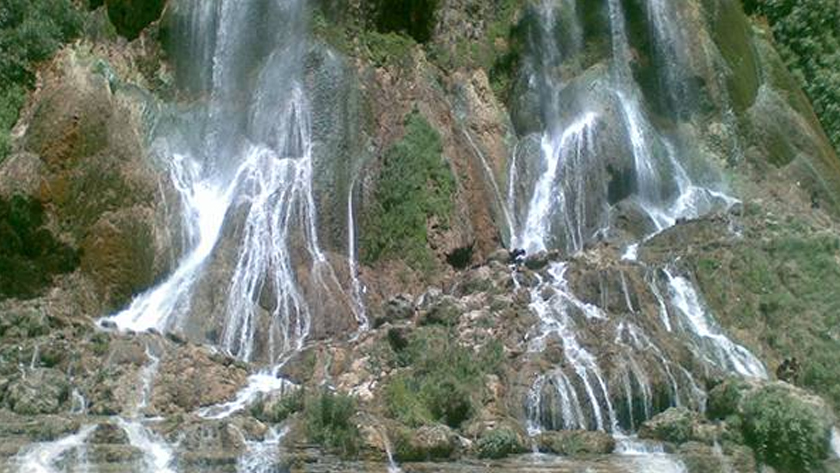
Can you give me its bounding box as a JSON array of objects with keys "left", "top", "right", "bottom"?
[{"left": 695, "top": 226, "right": 840, "bottom": 407}]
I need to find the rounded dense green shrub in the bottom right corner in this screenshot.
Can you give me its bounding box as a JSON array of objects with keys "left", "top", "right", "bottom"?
[{"left": 743, "top": 386, "right": 830, "bottom": 472}]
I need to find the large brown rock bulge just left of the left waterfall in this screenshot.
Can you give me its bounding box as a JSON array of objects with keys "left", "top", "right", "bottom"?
[{"left": 0, "top": 46, "right": 178, "bottom": 315}]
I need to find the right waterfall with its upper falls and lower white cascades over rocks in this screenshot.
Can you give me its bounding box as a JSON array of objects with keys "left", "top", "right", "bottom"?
[{"left": 507, "top": 0, "right": 766, "bottom": 454}]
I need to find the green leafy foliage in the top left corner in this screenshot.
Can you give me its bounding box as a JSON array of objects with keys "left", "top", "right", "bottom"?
[{"left": 0, "top": 0, "right": 83, "bottom": 161}]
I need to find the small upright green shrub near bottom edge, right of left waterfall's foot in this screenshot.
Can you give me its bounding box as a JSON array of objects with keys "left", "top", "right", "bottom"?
[{"left": 304, "top": 390, "right": 361, "bottom": 457}]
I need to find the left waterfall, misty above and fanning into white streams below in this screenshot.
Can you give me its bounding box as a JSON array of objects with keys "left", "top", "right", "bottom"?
[{"left": 105, "top": 0, "right": 354, "bottom": 365}]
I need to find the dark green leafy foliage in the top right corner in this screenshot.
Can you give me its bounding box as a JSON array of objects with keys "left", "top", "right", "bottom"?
[{"left": 744, "top": 0, "right": 840, "bottom": 150}]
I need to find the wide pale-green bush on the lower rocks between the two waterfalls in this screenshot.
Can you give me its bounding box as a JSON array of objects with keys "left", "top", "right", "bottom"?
[{"left": 385, "top": 326, "right": 502, "bottom": 428}]
